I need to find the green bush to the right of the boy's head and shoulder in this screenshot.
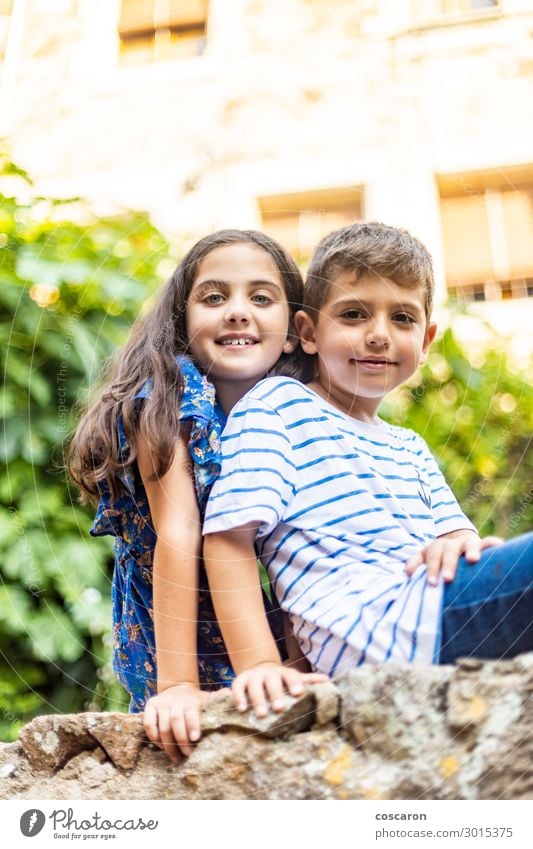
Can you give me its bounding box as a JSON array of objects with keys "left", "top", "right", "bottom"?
[{"left": 382, "top": 320, "right": 533, "bottom": 537}]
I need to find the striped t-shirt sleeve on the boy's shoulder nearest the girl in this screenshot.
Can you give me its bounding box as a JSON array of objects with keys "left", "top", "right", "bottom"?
[{"left": 204, "top": 396, "right": 295, "bottom": 536}]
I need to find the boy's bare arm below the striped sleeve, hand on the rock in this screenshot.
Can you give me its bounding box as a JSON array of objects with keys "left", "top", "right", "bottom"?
[{"left": 204, "top": 525, "right": 327, "bottom": 717}]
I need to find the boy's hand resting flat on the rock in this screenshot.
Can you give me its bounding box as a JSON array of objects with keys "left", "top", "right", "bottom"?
[{"left": 232, "top": 662, "right": 328, "bottom": 719}]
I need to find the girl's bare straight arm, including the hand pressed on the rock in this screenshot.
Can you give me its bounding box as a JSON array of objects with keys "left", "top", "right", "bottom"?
[{"left": 137, "top": 435, "right": 206, "bottom": 762}]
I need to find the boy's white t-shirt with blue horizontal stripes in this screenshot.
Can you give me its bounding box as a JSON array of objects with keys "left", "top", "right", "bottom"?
[{"left": 204, "top": 377, "right": 473, "bottom": 676}]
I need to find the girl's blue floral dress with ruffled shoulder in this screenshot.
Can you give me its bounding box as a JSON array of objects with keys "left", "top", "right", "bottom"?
[{"left": 90, "top": 357, "right": 234, "bottom": 712}]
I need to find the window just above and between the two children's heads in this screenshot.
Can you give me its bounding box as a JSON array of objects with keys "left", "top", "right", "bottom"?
[{"left": 259, "top": 187, "right": 362, "bottom": 261}]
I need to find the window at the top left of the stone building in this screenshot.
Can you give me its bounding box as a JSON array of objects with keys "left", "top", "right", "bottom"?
[{"left": 118, "top": 0, "right": 209, "bottom": 64}]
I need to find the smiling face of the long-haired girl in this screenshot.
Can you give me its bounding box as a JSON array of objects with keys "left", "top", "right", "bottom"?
[{"left": 187, "top": 242, "right": 296, "bottom": 411}]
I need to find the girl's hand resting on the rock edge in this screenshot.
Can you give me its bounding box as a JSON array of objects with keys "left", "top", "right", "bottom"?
[{"left": 144, "top": 681, "right": 209, "bottom": 764}]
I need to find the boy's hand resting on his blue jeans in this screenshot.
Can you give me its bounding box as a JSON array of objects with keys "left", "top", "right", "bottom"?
[{"left": 405, "top": 530, "right": 503, "bottom": 586}]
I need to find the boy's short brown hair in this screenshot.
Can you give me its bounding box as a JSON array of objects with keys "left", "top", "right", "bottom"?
[{"left": 304, "top": 221, "right": 435, "bottom": 319}]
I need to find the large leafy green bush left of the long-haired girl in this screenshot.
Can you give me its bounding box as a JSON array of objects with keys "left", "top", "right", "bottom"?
[{"left": 0, "top": 155, "right": 168, "bottom": 738}]
